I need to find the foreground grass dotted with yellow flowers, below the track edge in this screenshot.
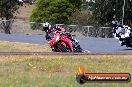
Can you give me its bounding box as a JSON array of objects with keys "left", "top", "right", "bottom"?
[{"left": 0, "top": 55, "right": 132, "bottom": 87}]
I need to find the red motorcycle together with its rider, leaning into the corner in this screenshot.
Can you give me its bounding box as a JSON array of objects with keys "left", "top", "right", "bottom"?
[{"left": 43, "top": 23, "right": 83, "bottom": 52}]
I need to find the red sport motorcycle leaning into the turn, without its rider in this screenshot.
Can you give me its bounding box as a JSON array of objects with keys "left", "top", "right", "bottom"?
[{"left": 48, "top": 31, "right": 74, "bottom": 52}]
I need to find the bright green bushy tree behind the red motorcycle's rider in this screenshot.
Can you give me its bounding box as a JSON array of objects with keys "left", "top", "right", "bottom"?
[{"left": 30, "top": 0, "right": 81, "bottom": 24}]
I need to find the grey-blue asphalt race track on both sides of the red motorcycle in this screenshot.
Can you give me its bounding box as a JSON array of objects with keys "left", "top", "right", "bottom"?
[{"left": 0, "top": 33, "right": 132, "bottom": 54}]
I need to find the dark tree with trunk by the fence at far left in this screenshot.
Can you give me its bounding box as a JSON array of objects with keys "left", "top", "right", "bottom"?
[{"left": 0, "top": 0, "right": 20, "bottom": 34}]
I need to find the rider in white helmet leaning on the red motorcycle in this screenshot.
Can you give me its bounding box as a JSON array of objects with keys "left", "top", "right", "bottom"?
[{"left": 43, "top": 22, "right": 84, "bottom": 52}]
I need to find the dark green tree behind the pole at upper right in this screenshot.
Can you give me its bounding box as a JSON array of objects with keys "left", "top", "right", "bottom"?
[{"left": 87, "top": 0, "right": 132, "bottom": 25}]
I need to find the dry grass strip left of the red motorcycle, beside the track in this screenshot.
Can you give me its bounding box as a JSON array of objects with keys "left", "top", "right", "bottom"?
[{"left": 0, "top": 41, "right": 51, "bottom": 52}]
